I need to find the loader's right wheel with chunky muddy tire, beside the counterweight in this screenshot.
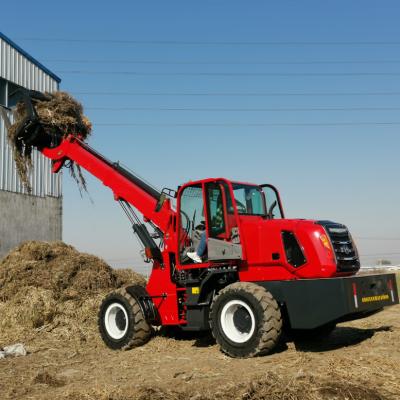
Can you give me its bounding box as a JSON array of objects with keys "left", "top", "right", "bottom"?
[{"left": 210, "top": 282, "right": 282, "bottom": 358}]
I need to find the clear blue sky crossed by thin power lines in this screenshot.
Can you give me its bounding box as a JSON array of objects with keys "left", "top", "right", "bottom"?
[{"left": 1, "top": 1, "right": 400, "bottom": 266}]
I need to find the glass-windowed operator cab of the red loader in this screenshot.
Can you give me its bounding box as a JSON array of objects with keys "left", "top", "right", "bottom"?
[{"left": 178, "top": 179, "right": 283, "bottom": 266}]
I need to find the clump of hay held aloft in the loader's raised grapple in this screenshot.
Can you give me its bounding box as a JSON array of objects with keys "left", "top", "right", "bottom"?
[{"left": 8, "top": 92, "right": 92, "bottom": 191}]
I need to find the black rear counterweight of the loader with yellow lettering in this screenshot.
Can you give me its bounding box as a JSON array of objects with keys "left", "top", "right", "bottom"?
[{"left": 257, "top": 274, "right": 399, "bottom": 329}]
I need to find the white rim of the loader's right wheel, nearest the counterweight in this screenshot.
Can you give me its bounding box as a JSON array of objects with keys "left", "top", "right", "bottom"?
[{"left": 220, "top": 300, "right": 256, "bottom": 343}]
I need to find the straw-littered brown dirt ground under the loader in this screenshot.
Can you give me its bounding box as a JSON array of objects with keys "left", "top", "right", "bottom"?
[{"left": 0, "top": 242, "right": 400, "bottom": 400}]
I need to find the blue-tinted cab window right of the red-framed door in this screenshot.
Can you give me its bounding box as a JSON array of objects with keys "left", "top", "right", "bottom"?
[{"left": 232, "top": 183, "right": 265, "bottom": 216}]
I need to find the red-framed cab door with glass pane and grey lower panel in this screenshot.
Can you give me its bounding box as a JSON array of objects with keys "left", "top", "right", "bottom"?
[{"left": 205, "top": 181, "right": 242, "bottom": 261}]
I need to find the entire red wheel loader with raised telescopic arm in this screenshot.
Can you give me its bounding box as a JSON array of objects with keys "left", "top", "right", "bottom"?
[{"left": 2, "top": 93, "right": 399, "bottom": 357}]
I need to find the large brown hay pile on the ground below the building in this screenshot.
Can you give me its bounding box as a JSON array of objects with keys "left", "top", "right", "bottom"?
[{"left": 0, "top": 242, "right": 145, "bottom": 346}]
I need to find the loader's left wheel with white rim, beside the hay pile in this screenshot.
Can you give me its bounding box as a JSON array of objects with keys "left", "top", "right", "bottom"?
[{"left": 98, "top": 288, "right": 151, "bottom": 350}]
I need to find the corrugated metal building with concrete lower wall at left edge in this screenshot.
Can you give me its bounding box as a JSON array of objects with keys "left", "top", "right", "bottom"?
[{"left": 0, "top": 32, "right": 62, "bottom": 257}]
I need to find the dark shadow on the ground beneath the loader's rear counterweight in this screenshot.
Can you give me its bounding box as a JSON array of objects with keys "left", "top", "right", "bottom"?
[{"left": 291, "top": 325, "right": 392, "bottom": 352}]
